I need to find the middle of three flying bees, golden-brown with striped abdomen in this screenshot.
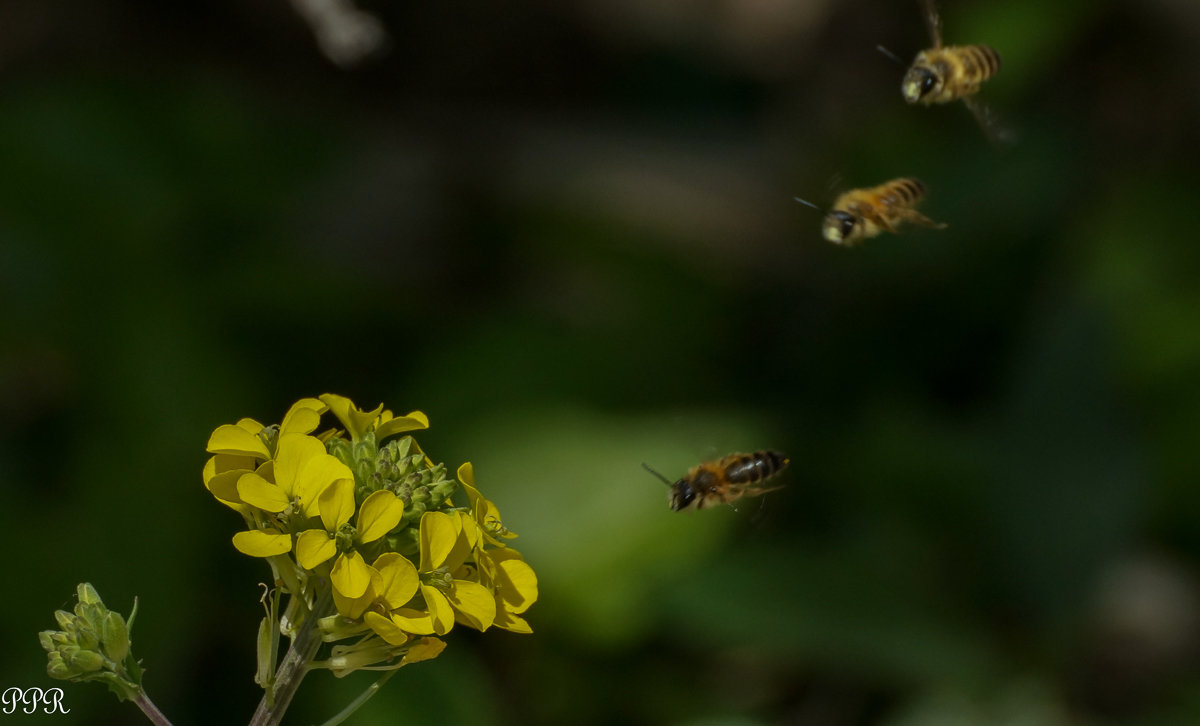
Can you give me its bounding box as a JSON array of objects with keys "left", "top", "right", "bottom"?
[{"left": 796, "top": 176, "right": 946, "bottom": 246}]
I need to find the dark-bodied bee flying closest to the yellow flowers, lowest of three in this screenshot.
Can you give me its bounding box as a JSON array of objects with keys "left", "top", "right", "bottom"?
[{"left": 642, "top": 451, "right": 788, "bottom": 511}]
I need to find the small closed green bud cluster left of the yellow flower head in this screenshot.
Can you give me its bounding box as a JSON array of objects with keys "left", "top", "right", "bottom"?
[{"left": 37, "top": 582, "right": 142, "bottom": 701}]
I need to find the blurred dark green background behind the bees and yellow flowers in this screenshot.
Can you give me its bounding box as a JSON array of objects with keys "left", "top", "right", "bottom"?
[{"left": 7, "top": 0, "right": 1200, "bottom": 726}]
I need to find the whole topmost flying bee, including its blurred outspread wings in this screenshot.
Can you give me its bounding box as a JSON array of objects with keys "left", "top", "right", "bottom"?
[{"left": 900, "top": 0, "right": 1010, "bottom": 143}]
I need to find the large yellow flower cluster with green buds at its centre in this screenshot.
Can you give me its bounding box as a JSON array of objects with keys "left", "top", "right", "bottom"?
[{"left": 203, "top": 394, "right": 538, "bottom": 672}]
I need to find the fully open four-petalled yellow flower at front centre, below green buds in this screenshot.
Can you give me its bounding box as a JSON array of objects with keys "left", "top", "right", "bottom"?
[{"left": 296, "top": 479, "right": 404, "bottom": 600}]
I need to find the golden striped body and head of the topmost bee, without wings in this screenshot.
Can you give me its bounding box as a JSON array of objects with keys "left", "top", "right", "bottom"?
[{"left": 900, "top": 44, "right": 1000, "bottom": 106}]
